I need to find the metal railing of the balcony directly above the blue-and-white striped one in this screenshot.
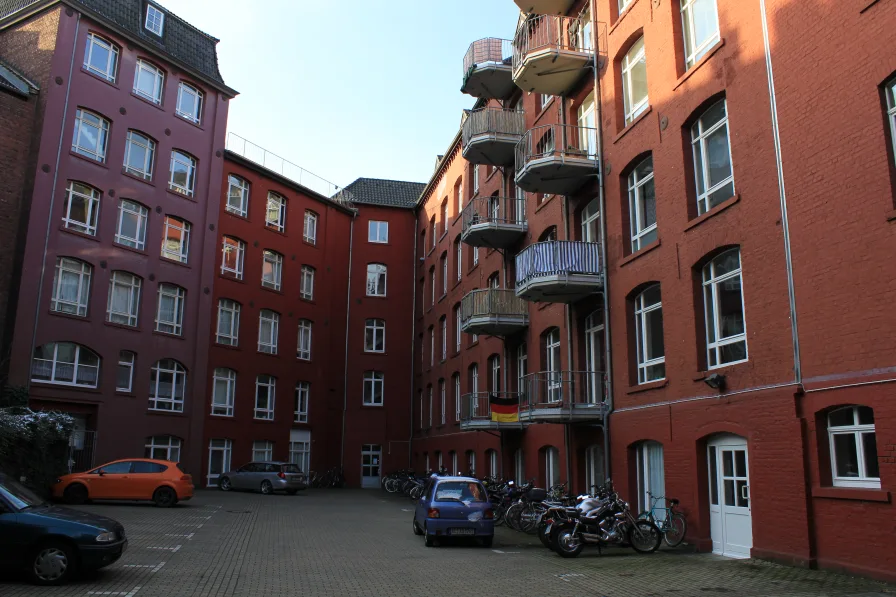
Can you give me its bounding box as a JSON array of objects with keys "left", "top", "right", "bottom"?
[{"left": 514, "top": 124, "right": 597, "bottom": 172}]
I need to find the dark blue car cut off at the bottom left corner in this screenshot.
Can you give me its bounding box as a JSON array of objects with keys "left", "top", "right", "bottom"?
[{"left": 0, "top": 473, "right": 128, "bottom": 585}]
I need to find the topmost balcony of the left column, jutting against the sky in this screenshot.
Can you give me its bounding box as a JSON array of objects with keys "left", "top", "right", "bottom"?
[{"left": 460, "top": 37, "right": 516, "bottom": 100}]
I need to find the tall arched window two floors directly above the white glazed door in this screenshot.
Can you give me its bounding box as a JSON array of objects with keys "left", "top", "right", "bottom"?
[{"left": 691, "top": 100, "right": 734, "bottom": 214}]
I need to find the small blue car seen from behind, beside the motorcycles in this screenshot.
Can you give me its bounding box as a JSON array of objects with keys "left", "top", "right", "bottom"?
[{"left": 414, "top": 476, "right": 495, "bottom": 547}]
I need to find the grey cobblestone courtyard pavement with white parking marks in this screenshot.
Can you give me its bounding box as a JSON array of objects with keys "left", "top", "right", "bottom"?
[{"left": 0, "top": 490, "right": 896, "bottom": 597}]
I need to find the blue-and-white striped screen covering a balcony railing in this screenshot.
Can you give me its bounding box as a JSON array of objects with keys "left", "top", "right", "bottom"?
[{"left": 516, "top": 240, "right": 601, "bottom": 286}]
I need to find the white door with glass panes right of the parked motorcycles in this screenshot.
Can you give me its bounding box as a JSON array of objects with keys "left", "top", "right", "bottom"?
[{"left": 708, "top": 435, "right": 753, "bottom": 558}]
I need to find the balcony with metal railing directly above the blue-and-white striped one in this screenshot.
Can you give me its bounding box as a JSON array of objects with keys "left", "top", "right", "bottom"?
[{"left": 514, "top": 124, "right": 600, "bottom": 195}]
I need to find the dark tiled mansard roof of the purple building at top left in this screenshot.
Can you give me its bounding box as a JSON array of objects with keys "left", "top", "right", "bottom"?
[{"left": 0, "top": 0, "right": 236, "bottom": 95}]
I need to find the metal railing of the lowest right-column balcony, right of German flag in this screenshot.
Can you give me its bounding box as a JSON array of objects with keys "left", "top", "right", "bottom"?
[{"left": 520, "top": 371, "right": 607, "bottom": 414}]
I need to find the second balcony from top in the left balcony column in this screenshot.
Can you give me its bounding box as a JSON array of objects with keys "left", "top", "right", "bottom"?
[{"left": 462, "top": 108, "right": 526, "bottom": 166}]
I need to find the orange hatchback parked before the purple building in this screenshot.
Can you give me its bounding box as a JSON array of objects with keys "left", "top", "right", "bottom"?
[{"left": 53, "top": 458, "right": 193, "bottom": 508}]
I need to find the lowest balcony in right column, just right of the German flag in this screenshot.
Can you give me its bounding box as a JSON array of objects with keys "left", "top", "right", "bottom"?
[{"left": 520, "top": 371, "right": 609, "bottom": 423}]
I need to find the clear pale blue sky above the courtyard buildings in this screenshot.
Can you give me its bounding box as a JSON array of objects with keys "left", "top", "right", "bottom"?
[{"left": 160, "top": 0, "right": 519, "bottom": 186}]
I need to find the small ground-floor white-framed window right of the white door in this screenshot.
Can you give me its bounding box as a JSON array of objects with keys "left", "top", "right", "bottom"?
[{"left": 828, "top": 406, "right": 880, "bottom": 489}]
